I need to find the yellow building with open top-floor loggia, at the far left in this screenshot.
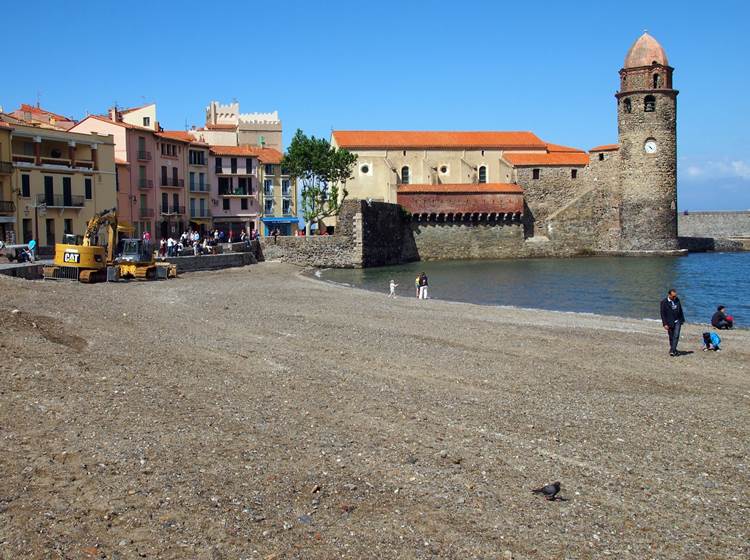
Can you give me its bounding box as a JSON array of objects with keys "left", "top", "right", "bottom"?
[{"left": 0, "top": 115, "right": 117, "bottom": 248}]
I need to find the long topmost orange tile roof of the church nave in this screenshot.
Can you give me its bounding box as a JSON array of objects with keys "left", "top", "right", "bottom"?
[{"left": 333, "top": 130, "right": 547, "bottom": 149}]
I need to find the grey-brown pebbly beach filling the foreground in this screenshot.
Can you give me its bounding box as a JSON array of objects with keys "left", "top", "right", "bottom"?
[{"left": 0, "top": 263, "right": 750, "bottom": 560}]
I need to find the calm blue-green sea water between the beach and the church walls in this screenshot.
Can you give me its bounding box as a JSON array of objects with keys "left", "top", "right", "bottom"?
[{"left": 322, "top": 253, "right": 750, "bottom": 326}]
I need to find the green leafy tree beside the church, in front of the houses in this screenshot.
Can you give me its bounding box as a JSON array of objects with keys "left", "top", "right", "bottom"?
[{"left": 281, "top": 130, "right": 357, "bottom": 235}]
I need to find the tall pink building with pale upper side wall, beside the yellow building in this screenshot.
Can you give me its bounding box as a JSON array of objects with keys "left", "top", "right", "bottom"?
[{"left": 71, "top": 111, "right": 161, "bottom": 236}]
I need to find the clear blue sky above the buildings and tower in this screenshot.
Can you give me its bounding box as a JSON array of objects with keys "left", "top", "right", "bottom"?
[{"left": 0, "top": 0, "right": 750, "bottom": 210}]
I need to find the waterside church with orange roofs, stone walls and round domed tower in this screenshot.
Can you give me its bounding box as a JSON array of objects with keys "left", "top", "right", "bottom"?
[{"left": 331, "top": 33, "right": 678, "bottom": 258}]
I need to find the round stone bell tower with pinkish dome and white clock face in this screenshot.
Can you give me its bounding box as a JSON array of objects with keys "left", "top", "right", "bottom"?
[{"left": 616, "top": 33, "right": 678, "bottom": 251}]
